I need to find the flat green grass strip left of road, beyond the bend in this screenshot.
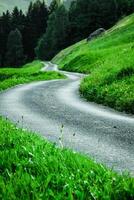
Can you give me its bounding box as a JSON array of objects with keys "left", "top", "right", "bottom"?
[{"left": 0, "top": 61, "right": 64, "bottom": 91}]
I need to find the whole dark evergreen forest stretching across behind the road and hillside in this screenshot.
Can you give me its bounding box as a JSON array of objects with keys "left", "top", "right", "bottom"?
[{"left": 0, "top": 0, "right": 134, "bottom": 67}]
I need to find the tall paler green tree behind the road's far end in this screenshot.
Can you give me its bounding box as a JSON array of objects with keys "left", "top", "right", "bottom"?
[{"left": 36, "top": 5, "right": 69, "bottom": 60}]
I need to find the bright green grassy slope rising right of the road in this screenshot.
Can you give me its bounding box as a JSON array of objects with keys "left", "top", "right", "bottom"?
[{"left": 53, "top": 15, "right": 134, "bottom": 114}]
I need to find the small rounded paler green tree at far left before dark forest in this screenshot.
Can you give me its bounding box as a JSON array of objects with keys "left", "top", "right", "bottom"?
[{"left": 6, "top": 29, "right": 24, "bottom": 67}]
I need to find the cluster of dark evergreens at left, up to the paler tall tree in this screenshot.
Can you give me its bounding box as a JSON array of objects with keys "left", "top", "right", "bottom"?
[{"left": 0, "top": 0, "right": 49, "bottom": 67}]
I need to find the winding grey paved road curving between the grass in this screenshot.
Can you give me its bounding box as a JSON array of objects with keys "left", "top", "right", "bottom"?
[{"left": 0, "top": 63, "right": 134, "bottom": 174}]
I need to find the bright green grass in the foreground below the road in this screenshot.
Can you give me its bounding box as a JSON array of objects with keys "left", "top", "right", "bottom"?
[{"left": 0, "top": 119, "right": 134, "bottom": 200}]
